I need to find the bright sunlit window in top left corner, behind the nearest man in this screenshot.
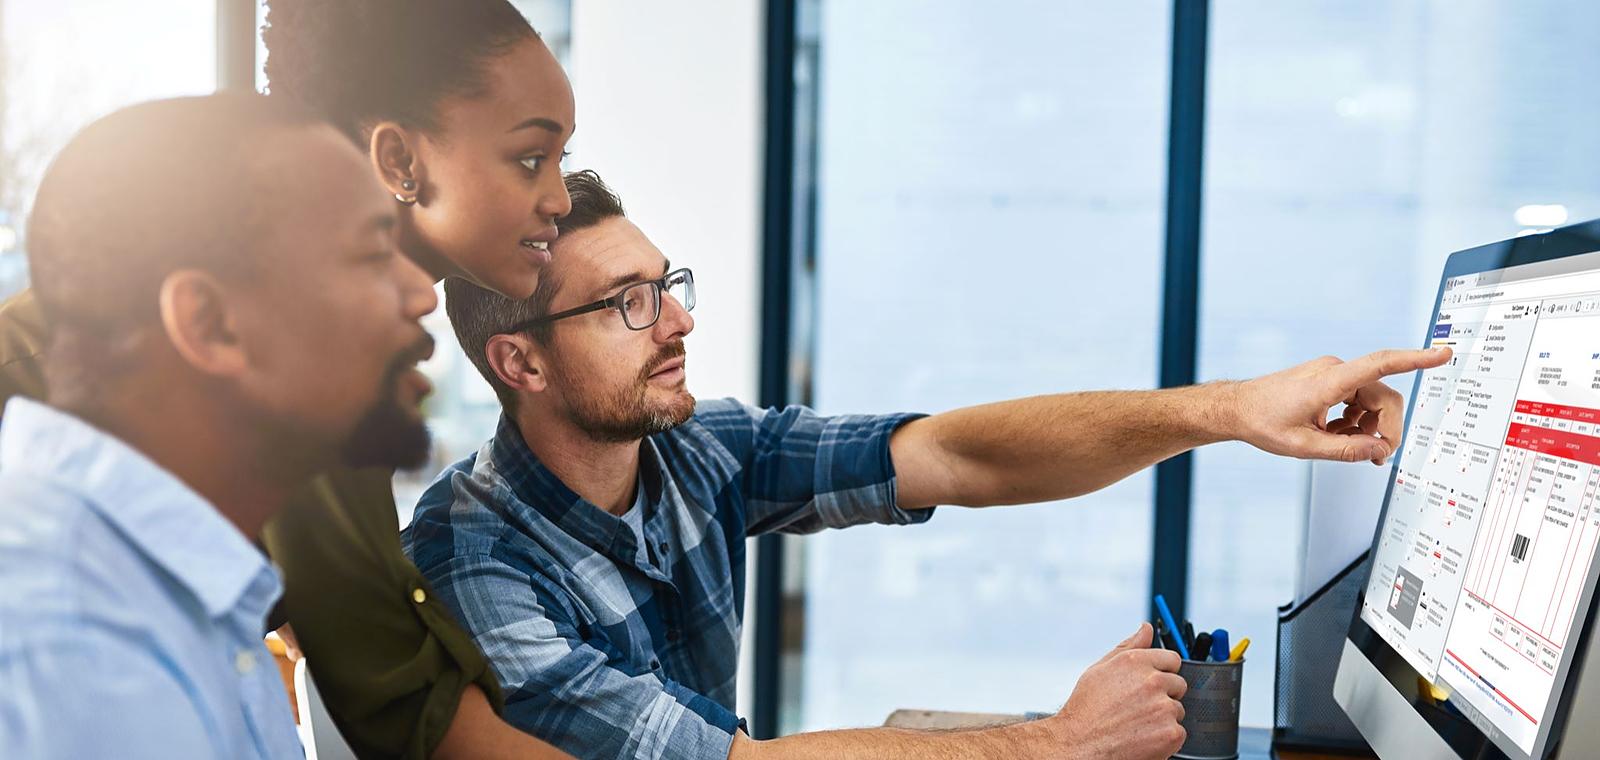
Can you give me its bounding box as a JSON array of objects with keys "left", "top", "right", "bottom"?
[{"left": 0, "top": 0, "right": 216, "bottom": 298}]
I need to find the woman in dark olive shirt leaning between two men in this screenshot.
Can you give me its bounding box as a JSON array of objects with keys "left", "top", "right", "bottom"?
[{"left": 262, "top": 0, "right": 573, "bottom": 757}]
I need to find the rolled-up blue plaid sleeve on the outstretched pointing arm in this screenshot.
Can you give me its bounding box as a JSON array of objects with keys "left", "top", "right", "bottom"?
[{"left": 696, "top": 400, "right": 933, "bottom": 536}]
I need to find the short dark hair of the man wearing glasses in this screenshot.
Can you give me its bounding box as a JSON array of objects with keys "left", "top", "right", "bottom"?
[{"left": 445, "top": 170, "right": 627, "bottom": 410}]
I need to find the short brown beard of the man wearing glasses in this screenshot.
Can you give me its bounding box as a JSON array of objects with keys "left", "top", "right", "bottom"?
[{"left": 555, "top": 341, "right": 694, "bottom": 443}]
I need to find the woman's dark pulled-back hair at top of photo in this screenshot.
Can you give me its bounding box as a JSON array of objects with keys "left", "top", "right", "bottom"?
[{"left": 261, "top": 0, "right": 538, "bottom": 149}]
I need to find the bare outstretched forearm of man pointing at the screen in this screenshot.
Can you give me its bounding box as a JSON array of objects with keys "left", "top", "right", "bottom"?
[{"left": 891, "top": 382, "right": 1237, "bottom": 509}]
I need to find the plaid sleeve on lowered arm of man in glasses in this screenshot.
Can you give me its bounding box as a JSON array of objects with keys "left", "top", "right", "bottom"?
[{"left": 429, "top": 554, "right": 739, "bottom": 760}]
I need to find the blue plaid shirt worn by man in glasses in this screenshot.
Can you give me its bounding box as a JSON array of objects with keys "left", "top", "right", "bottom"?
[{"left": 402, "top": 400, "right": 933, "bottom": 760}]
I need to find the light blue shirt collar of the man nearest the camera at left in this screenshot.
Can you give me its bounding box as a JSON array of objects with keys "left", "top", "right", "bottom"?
[{"left": 0, "top": 397, "right": 282, "bottom": 619}]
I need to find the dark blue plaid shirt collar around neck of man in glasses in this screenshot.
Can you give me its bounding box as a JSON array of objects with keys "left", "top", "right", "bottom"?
[{"left": 490, "top": 414, "right": 672, "bottom": 581}]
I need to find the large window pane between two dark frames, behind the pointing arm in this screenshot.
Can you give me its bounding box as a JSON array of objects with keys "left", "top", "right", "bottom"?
[{"left": 793, "top": 0, "right": 1171, "bottom": 731}]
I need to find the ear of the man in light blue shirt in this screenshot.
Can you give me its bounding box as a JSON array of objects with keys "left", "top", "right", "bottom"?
[{"left": 158, "top": 269, "right": 250, "bottom": 376}]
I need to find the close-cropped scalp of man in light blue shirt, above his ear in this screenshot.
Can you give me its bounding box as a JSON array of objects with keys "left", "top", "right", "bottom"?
[{"left": 27, "top": 94, "right": 331, "bottom": 338}]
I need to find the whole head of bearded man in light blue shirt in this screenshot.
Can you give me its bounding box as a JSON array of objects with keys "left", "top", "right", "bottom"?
[{"left": 29, "top": 93, "right": 438, "bottom": 472}]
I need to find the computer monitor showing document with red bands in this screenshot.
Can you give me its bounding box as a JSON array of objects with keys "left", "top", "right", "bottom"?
[{"left": 1334, "top": 221, "right": 1600, "bottom": 760}]
